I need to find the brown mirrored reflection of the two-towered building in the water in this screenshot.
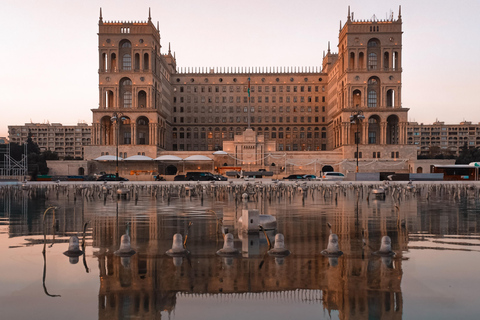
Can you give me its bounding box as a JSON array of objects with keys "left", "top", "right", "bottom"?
[{"left": 94, "top": 196, "right": 407, "bottom": 319}]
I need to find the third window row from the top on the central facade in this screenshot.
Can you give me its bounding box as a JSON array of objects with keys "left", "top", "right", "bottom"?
[{"left": 173, "top": 96, "right": 325, "bottom": 103}]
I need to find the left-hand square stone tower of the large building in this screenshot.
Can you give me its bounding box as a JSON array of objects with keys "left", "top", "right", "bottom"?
[{"left": 92, "top": 9, "right": 176, "bottom": 157}]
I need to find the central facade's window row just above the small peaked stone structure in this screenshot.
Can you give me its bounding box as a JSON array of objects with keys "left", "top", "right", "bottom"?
[{"left": 173, "top": 116, "right": 326, "bottom": 123}]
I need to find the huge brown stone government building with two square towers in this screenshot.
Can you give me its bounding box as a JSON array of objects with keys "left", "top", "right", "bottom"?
[{"left": 86, "top": 5, "right": 416, "bottom": 170}]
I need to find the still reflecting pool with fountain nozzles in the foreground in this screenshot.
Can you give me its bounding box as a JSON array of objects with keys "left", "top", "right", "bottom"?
[{"left": 0, "top": 182, "right": 480, "bottom": 319}]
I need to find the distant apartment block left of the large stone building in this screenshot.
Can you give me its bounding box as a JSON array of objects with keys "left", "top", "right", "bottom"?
[{"left": 8, "top": 123, "right": 92, "bottom": 159}]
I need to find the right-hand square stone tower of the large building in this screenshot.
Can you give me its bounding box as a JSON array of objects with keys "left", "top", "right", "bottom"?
[{"left": 323, "top": 7, "right": 409, "bottom": 162}]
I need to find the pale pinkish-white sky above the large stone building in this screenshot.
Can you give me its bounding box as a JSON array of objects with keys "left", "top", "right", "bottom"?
[{"left": 0, "top": 0, "right": 480, "bottom": 137}]
